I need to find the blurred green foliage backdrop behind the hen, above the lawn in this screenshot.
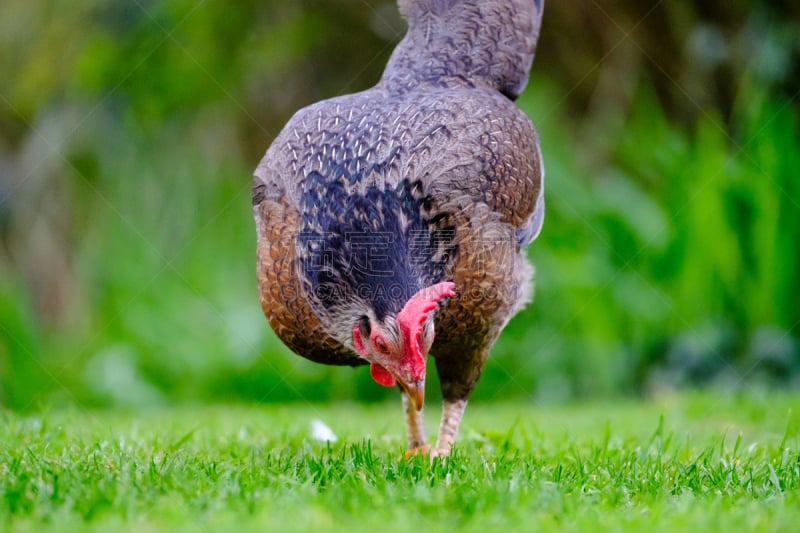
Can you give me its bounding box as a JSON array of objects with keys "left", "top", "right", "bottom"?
[{"left": 0, "top": 0, "right": 800, "bottom": 410}]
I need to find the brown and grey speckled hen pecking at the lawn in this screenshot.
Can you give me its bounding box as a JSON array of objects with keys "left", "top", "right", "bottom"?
[{"left": 253, "top": 0, "right": 544, "bottom": 455}]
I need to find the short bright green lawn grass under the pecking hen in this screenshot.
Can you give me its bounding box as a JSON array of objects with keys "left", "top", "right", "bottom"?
[{"left": 0, "top": 393, "right": 800, "bottom": 532}]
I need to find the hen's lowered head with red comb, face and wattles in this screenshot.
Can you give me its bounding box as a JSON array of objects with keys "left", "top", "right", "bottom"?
[{"left": 353, "top": 281, "right": 455, "bottom": 410}]
